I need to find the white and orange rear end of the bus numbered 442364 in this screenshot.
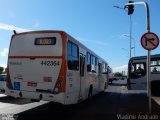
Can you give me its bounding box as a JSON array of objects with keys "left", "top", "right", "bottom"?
[{"left": 7, "top": 32, "right": 66, "bottom": 104}]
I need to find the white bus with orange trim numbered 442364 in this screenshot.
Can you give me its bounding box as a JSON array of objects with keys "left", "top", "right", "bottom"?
[{"left": 7, "top": 30, "right": 108, "bottom": 104}]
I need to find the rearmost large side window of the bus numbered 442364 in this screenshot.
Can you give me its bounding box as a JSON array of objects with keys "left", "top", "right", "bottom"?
[{"left": 67, "top": 41, "right": 79, "bottom": 70}]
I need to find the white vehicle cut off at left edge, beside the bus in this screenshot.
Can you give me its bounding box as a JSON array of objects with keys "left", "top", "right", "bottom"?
[{"left": 0, "top": 74, "right": 6, "bottom": 92}]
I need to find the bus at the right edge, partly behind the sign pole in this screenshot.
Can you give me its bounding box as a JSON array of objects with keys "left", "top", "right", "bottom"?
[{"left": 128, "top": 54, "right": 160, "bottom": 95}]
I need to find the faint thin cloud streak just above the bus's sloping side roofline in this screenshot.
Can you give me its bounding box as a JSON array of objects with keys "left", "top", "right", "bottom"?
[{"left": 76, "top": 37, "right": 111, "bottom": 46}]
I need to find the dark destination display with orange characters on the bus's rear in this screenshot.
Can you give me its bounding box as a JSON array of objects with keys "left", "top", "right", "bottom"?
[{"left": 34, "top": 37, "right": 56, "bottom": 45}]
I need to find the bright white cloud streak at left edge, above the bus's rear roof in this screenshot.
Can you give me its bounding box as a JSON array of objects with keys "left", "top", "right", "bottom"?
[{"left": 0, "top": 22, "right": 31, "bottom": 32}]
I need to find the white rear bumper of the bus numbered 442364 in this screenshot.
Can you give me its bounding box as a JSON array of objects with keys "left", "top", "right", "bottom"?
[{"left": 6, "top": 89, "right": 65, "bottom": 104}]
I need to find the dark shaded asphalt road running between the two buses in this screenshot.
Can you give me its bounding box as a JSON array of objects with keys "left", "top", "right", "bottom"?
[{"left": 0, "top": 80, "right": 160, "bottom": 120}]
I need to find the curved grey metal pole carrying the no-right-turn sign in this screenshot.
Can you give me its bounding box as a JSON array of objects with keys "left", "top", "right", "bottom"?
[{"left": 125, "top": 2, "right": 151, "bottom": 113}]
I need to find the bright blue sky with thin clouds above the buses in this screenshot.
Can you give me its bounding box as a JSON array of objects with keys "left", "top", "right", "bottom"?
[{"left": 0, "top": 0, "right": 160, "bottom": 72}]
